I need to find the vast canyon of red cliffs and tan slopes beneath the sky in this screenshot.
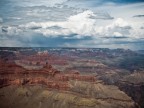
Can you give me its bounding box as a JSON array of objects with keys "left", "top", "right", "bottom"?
[{"left": 0, "top": 49, "right": 143, "bottom": 108}]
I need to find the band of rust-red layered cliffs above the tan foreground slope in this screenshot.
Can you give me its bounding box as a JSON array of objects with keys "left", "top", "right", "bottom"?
[{"left": 0, "top": 58, "right": 95, "bottom": 89}]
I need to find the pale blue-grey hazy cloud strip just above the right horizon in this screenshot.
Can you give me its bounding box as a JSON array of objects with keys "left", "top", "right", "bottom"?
[{"left": 60, "top": 38, "right": 144, "bottom": 50}]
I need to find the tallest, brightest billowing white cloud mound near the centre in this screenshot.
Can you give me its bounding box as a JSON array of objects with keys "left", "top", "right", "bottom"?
[{"left": 62, "top": 10, "right": 96, "bottom": 35}]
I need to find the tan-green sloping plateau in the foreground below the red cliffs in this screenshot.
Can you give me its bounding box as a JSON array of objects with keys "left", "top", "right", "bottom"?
[{"left": 0, "top": 85, "right": 136, "bottom": 108}]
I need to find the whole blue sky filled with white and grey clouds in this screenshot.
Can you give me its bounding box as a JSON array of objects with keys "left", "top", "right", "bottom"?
[{"left": 0, "top": 0, "right": 144, "bottom": 50}]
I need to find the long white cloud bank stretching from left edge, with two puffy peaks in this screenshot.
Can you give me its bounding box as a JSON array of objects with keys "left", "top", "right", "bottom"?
[{"left": 1, "top": 10, "right": 132, "bottom": 39}]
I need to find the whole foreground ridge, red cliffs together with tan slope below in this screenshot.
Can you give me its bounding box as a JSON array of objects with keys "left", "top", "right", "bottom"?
[{"left": 0, "top": 52, "right": 138, "bottom": 108}]
